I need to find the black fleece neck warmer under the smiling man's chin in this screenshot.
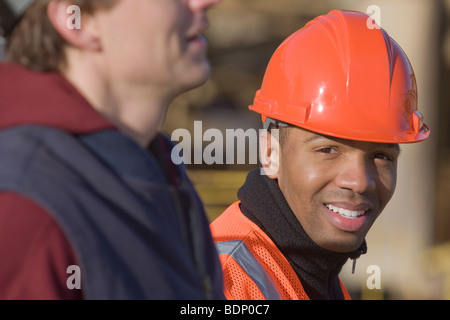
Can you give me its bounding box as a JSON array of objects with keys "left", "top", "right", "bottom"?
[{"left": 238, "top": 169, "right": 367, "bottom": 299}]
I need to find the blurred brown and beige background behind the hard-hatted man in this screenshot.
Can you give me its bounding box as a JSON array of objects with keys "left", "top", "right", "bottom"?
[{"left": 164, "top": 0, "right": 450, "bottom": 299}]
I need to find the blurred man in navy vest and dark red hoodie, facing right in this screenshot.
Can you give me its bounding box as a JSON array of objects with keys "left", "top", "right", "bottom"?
[{"left": 0, "top": 0, "right": 223, "bottom": 299}]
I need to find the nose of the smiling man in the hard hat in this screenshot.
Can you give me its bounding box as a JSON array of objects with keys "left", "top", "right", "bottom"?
[{"left": 336, "top": 156, "right": 377, "bottom": 194}]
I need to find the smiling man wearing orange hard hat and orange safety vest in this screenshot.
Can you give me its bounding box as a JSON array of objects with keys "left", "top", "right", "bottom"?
[{"left": 211, "top": 10, "right": 430, "bottom": 300}]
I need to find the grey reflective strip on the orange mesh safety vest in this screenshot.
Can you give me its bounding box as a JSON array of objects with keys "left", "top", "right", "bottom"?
[{"left": 216, "top": 240, "right": 281, "bottom": 300}]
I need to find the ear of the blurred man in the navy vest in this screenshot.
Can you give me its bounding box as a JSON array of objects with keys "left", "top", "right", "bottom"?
[{"left": 47, "top": 0, "right": 101, "bottom": 51}]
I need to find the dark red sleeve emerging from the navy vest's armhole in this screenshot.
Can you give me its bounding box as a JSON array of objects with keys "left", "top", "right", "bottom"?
[{"left": 0, "top": 192, "right": 82, "bottom": 300}]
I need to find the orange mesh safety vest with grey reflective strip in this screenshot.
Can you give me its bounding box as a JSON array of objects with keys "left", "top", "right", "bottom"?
[{"left": 211, "top": 201, "right": 351, "bottom": 300}]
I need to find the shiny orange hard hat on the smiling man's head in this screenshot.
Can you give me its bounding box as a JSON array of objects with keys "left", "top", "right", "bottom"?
[{"left": 249, "top": 10, "right": 430, "bottom": 143}]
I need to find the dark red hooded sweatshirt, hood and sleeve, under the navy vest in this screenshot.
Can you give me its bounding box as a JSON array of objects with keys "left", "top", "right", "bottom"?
[{"left": 0, "top": 63, "right": 114, "bottom": 300}]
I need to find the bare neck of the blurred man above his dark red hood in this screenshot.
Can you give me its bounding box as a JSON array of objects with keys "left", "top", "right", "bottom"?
[{"left": 63, "top": 52, "right": 172, "bottom": 147}]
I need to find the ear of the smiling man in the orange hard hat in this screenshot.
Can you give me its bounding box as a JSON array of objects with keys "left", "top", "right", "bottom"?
[{"left": 259, "top": 129, "right": 280, "bottom": 179}]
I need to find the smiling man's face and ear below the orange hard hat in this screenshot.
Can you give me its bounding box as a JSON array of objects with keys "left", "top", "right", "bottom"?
[{"left": 260, "top": 127, "right": 400, "bottom": 252}]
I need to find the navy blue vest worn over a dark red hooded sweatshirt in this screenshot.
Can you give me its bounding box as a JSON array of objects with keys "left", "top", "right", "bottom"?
[{"left": 0, "top": 125, "right": 223, "bottom": 299}]
